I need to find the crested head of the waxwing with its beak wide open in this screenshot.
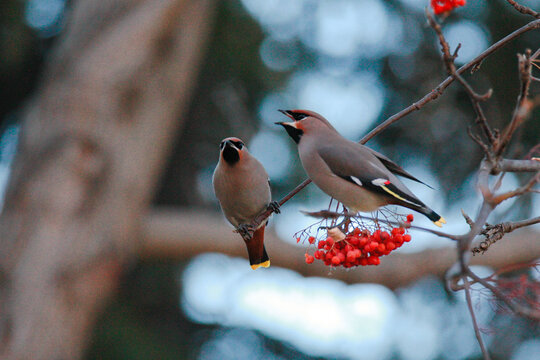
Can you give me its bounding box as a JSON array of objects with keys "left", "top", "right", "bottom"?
[{"left": 276, "top": 110, "right": 336, "bottom": 144}]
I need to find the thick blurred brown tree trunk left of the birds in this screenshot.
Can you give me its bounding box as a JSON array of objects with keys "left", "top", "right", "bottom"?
[{"left": 0, "top": 0, "right": 214, "bottom": 359}]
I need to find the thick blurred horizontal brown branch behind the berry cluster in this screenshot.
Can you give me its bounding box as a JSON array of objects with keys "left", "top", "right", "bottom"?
[{"left": 138, "top": 208, "right": 540, "bottom": 288}]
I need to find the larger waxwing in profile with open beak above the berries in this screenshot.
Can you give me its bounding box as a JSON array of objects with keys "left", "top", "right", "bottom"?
[{"left": 276, "top": 110, "right": 446, "bottom": 227}]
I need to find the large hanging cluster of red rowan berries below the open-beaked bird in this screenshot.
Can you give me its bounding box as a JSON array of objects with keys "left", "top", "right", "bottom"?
[{"left": 304, "top": 214, "right": 414, "bottom": 268}]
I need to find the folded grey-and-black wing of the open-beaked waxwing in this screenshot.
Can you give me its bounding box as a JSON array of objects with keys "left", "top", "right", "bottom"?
[{"left": 317, "top": 143, "right": 425, "bottom": 206}]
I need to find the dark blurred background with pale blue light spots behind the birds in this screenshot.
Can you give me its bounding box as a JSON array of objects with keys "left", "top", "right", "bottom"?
[{"left": 0, "top": 0, "right": 540, "bottom": 360}]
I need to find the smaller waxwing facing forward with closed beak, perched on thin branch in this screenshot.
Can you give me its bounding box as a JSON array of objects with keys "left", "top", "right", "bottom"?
[{"left": 212, "top": 137, "right": 279, "bottom": 270}]
